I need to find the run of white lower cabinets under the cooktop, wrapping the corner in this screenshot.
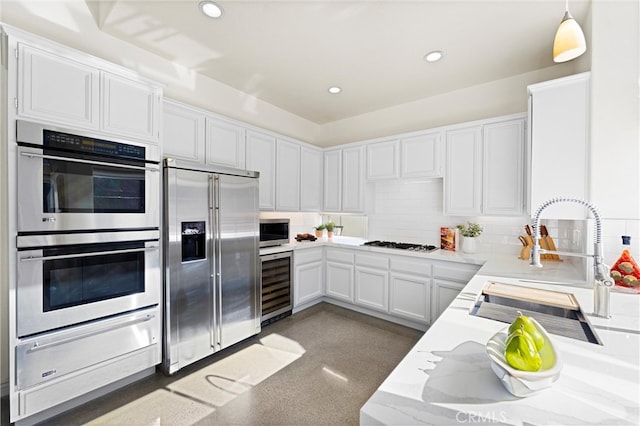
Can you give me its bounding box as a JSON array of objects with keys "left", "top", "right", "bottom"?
[{"left": 294, "top": 246, "right": 480, "bottom": 329}]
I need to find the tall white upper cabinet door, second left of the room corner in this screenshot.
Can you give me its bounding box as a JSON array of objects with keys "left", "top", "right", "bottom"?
[{"left": 276, "top": 139, "right": 300, "bottom": 211}]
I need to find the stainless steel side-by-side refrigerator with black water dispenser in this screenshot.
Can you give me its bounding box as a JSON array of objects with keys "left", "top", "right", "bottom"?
[{"left": 162, "top": 159, "right": 261, "bottom": 374}]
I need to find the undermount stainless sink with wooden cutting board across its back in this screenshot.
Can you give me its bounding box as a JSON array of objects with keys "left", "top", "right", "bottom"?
[{"left": 469, "top": 282, "right": 602, "bottom": 345}]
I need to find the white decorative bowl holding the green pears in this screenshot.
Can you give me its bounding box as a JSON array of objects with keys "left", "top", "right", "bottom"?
[{"left": 487, "top": 318, "right": 562, "bottom": 397}]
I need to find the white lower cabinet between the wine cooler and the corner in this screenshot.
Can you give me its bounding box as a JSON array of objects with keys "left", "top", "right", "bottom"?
[{"left": 293, "top": 247, "right": 324, "bottom": 308}]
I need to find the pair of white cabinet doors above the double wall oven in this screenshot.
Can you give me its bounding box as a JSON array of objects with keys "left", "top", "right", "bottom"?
[{"left": 16, "top": 42, "right": 162, "bottom": 142}]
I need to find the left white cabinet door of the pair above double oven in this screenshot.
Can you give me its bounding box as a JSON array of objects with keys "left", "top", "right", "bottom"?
[{"left": 17, "top": 43, "right": 100, "bottom": 129}]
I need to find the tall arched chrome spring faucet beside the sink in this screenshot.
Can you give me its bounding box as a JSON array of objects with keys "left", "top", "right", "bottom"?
[{"left": 529, "top": 197, "right": 614, "bottom": 318}]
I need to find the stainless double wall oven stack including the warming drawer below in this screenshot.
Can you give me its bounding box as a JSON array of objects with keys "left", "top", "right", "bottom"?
[{"left": 12, "top": 120, "right": 162, "bottom": 418}]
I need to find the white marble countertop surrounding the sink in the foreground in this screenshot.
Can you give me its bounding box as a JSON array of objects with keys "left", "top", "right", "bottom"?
[{"left": 360, "top": 256, "right": 640, "bottom": 425}]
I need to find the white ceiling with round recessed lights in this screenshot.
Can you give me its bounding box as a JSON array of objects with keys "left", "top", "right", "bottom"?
[{"left": 90, "top": 0, "right": 591, "bottom": 124}]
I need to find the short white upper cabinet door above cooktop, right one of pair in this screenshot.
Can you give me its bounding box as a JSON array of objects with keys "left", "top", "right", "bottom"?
[{"left": 400, "top": 132, "right": 442, "bottom": 178}]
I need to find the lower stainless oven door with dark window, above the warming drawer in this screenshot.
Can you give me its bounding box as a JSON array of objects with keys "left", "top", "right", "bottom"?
[{"left": 16, "top": 231, "right": 162, "bottom": 337}]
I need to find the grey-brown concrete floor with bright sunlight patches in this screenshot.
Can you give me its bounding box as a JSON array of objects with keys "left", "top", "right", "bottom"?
[{"left": 2, "top": 303, "right": 423, "bottom": 426}]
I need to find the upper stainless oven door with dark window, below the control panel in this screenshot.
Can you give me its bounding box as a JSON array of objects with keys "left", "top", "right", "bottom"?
[{"left": 18, "top": 146, "right": 160, "bottom": 233}]
